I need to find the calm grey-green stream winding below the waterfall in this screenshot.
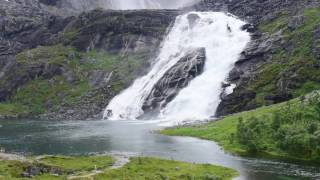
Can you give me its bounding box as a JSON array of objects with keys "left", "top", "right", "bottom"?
[{"left": 0, "top": 120, "right": 320, "bottom": 180}]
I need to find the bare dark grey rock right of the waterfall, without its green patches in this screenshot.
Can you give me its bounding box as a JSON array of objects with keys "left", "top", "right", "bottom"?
[{"left": 192, "top": 0, "right": 320, "bottom": 115}]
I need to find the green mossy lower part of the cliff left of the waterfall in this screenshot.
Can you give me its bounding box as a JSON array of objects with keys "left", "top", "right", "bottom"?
[{"left": 0, "top": 44, "right": 147, "bottom": 119}]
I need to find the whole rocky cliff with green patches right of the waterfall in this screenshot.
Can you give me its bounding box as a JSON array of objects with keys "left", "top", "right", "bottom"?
[{"left": 192, "top": 0, "right": 320, "bottom": 116}]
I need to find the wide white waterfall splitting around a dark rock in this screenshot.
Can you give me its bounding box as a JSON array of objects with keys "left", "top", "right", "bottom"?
[{"left": 105, "top": 12, "right": 250, "bottom": 122}]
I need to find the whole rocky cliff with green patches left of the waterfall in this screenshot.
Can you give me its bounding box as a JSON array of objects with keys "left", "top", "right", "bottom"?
[{"left": 0, "top": 0, "right": 178, "bottom": 119}]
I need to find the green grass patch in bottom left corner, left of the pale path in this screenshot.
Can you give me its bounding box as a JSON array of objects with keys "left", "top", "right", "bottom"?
[{"left": 0, "top": 156, "right": 114, "bottom": 180}]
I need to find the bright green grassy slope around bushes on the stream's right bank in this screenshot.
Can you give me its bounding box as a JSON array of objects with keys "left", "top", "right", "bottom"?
[{"left": 161, "top": 95, "right": 319, "bottom": 162}]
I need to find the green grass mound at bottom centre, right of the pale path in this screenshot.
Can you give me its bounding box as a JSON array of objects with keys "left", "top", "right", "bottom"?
[{"left": 94, "top": 157, "right": 238, "bottom": 180}]
